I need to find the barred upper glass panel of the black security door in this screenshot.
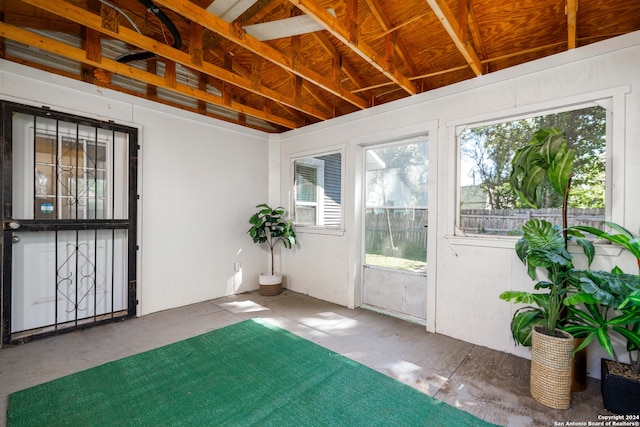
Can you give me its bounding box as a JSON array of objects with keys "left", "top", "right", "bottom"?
[{"left": 13, "top": 114, "right": 129, "bottom": 220}]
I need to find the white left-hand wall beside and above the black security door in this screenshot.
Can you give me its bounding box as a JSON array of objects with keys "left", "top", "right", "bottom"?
[{"left": 0, "top": 61, "right": 269, "bottom": 315}]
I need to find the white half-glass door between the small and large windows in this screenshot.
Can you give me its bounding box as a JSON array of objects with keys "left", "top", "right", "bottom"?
[{"left": 362, "top": 136, "right": 428, "bottom": 324}]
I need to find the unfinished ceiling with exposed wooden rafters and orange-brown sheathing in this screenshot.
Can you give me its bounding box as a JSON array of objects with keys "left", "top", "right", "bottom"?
[{"left": 0, "top": 0, "right": 640, "bottom": 132}]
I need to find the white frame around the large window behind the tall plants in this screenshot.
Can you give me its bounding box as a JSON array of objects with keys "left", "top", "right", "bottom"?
[{"left": 447, "top": 86, "right": 630, "bottom": 241}]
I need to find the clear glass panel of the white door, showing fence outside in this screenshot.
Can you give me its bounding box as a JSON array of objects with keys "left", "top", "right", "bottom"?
[{"left": 364, "top": 137, "right": 428, "bottom": 272}]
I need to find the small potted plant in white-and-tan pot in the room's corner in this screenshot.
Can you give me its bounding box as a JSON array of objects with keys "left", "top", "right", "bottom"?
[{"left": 247, "top": 203, "right": 296, "bottom": 296}]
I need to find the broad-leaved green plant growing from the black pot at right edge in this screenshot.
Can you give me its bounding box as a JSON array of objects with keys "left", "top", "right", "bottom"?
[{"left": 564, "top": 222, "right": 640, "bottom": 374}]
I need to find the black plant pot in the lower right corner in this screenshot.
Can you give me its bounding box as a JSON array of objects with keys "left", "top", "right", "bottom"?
[{"left": 600, "top": 359, "right": 640, "bottom": 415}]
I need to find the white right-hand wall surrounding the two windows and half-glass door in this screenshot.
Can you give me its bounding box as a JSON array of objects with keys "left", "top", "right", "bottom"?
[{"left": 278, "top": 32, "right": 640, "bottom": 377}]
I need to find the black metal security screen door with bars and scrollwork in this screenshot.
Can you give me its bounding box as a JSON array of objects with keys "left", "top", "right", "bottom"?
[{"left": 1, "top": 103, "right": 138, "bottom": 344}]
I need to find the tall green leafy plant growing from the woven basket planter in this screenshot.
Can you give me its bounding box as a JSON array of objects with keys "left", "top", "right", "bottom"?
[{"left": 500, "top": 128, "right": 595, "bottom": 346}]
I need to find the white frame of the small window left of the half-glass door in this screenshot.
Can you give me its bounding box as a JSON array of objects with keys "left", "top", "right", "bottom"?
[{"left": 287, "top": 146, "right": 346, "bottom": 235}]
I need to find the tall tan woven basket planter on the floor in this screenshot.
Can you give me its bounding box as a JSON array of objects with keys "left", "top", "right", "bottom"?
[{"left": 530, "top": 326, "right": 573, "bottom": 409}]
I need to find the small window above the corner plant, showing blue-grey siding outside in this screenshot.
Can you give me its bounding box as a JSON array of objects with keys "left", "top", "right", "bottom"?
[{"left": 293, "top": 153, "right": 342, "bottom": 227}]
